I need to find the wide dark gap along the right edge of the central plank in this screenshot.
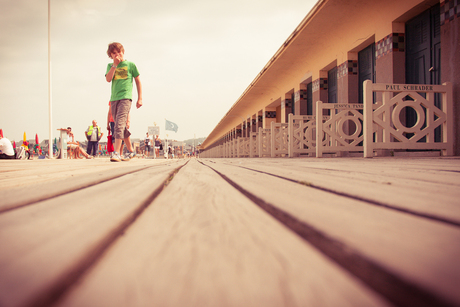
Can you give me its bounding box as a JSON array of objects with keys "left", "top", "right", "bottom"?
[{"left": 200, "top": 161, "right": 456, "bottom": 307}]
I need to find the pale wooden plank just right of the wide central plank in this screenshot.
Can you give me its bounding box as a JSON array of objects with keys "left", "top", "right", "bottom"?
[{"left": 199, "top": 160, "right": 460, "bottom": 305}]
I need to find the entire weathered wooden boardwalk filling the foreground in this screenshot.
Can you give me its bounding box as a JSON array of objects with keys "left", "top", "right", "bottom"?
[{"left": 0, "top": 157, "right": 460, "bottom": 307}]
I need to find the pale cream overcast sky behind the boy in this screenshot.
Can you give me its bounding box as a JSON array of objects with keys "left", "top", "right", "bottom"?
[{"left": 0, "top": 0, "right": 316, "bottom": 141}]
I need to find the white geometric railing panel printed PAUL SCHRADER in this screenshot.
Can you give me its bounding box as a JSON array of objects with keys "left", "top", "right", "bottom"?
[{"left": 364, "top": 81, "right": 454, "bottom": 157}]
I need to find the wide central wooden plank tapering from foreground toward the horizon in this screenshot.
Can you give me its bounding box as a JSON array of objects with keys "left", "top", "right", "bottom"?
[{"left": 58, "top": 160, "right": 386, "bottom": 306}]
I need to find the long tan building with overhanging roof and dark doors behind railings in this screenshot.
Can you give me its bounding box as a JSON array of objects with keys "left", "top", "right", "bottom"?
[{"left": 201, "top": 0, "right": 460, "bottom": 155}]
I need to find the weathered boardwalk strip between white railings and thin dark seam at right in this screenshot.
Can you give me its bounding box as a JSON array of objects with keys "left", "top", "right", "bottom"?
[{"left": 208, "top": 158, "right": 460, "bottom": 225}]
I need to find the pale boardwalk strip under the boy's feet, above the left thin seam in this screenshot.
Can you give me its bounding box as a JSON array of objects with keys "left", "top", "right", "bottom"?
[{"left": 0, "top": 159, "right": 183, "bottom": 212}]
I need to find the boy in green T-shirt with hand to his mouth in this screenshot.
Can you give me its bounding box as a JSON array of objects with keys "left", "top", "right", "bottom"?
[{"left": 105, "top": 43, "right": 142, "bottom": 162}]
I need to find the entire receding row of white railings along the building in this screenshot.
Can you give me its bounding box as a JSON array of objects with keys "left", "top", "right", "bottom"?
[{"left": 201, "top": 81, "right": 454, "bottom": 158}]
